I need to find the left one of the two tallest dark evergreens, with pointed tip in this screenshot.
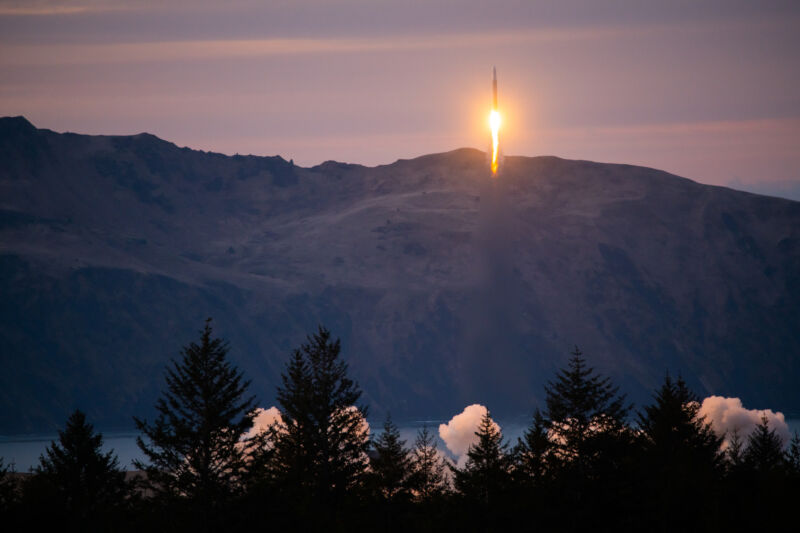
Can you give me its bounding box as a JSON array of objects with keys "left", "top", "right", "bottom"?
[{"left": 134, "top": 318, "right": 254, "bottom": 528}]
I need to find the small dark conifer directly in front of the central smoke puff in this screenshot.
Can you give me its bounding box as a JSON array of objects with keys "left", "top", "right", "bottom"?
[{"left": 453, "top": 411, "right": 511, "bottom": 507}]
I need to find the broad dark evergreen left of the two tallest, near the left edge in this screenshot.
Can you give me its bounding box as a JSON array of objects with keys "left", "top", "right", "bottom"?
[{"left": 24, "top": 410, "right": 130, "bottom": 531}]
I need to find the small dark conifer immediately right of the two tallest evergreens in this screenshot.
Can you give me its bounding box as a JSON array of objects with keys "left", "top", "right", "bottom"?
[{"left": 369, "top": 415, "right": 411, "bottom": 503}]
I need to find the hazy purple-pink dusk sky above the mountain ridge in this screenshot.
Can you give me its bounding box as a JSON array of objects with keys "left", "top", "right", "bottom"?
[{"left": 0, "top": 0, "right": 800, "bottom": 200}]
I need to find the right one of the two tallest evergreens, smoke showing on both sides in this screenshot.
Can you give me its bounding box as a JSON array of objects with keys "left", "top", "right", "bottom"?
[{"left": 256, "top": 327, "right": 369, "bottom": 520}]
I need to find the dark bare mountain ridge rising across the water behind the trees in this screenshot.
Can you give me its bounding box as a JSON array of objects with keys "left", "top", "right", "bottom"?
[{"left": 0, "top": 118, "right": 800, "bottom": 432}]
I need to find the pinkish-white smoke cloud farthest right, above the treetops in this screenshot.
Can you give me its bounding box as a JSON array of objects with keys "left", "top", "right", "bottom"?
[{"left": 698, "top": 396, "right": 790, "bottom": 449}]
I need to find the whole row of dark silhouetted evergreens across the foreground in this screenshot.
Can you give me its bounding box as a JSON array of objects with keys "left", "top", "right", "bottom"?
[{"left": 0, "top": 319, "right": 800, "bottom": 531}]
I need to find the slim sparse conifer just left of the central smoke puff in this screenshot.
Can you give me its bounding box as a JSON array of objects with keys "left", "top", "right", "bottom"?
[{"left": 410, "top": 425, "right": 450, "bottom": 502}]
